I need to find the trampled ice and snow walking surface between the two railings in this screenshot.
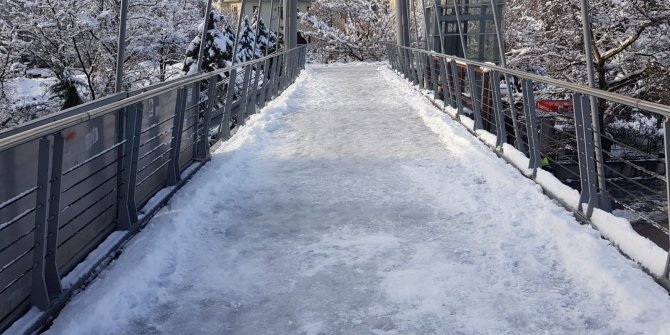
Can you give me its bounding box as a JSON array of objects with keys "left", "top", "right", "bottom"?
[{"left": 50, "top": 65, "right": 670, "bottom": 335}]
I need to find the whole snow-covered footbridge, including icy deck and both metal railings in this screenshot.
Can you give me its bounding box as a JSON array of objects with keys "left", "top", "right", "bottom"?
[{"left": 6, "top": 45, "right": 670, "bottom": 334}]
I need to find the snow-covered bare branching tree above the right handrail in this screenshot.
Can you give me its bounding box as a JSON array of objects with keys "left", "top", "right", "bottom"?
[{"left": 506, "top": 0, "right": 670, "bottom": 103}]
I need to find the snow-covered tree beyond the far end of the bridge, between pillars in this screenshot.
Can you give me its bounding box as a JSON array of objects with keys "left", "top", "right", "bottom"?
[{"left": 299, "top": 0, "right": 395, "bottom": 61}]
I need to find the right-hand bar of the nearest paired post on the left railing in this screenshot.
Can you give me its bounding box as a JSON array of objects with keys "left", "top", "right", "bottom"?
[{"left": 44, "top": 133, "right": 65, "bottom": 297}]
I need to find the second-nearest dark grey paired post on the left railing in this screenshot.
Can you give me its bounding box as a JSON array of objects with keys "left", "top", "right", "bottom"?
[{"left": 117, "top": 103, "right": 144, "bottom": 230}]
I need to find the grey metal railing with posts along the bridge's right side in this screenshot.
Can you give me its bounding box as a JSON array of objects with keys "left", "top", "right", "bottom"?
[{"left": 385, "top": 44, "right": 670, "bottom": 288}]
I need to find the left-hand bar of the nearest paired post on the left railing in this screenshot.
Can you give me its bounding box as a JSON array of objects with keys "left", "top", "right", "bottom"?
[{"left": 30, "top": 136, "right": 51, "bottom": 310}]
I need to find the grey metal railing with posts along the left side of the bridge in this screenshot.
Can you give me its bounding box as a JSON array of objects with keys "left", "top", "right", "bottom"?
[{"left": 0, "top": 46, "right": 306, "bottom": 332}]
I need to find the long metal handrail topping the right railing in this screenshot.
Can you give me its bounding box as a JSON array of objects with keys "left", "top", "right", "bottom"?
[{"left": 382, "top": 42, "right": 670, "bottom": 117}]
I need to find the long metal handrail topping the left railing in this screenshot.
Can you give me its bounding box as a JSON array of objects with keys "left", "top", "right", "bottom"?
[{"left": 0, "top": 45, "right": 307, "bottom": 151}]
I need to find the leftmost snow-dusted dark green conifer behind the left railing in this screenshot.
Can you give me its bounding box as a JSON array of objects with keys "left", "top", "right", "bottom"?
[{"left": 183, "top": 11, "right": 235, "bottom": 73}]
